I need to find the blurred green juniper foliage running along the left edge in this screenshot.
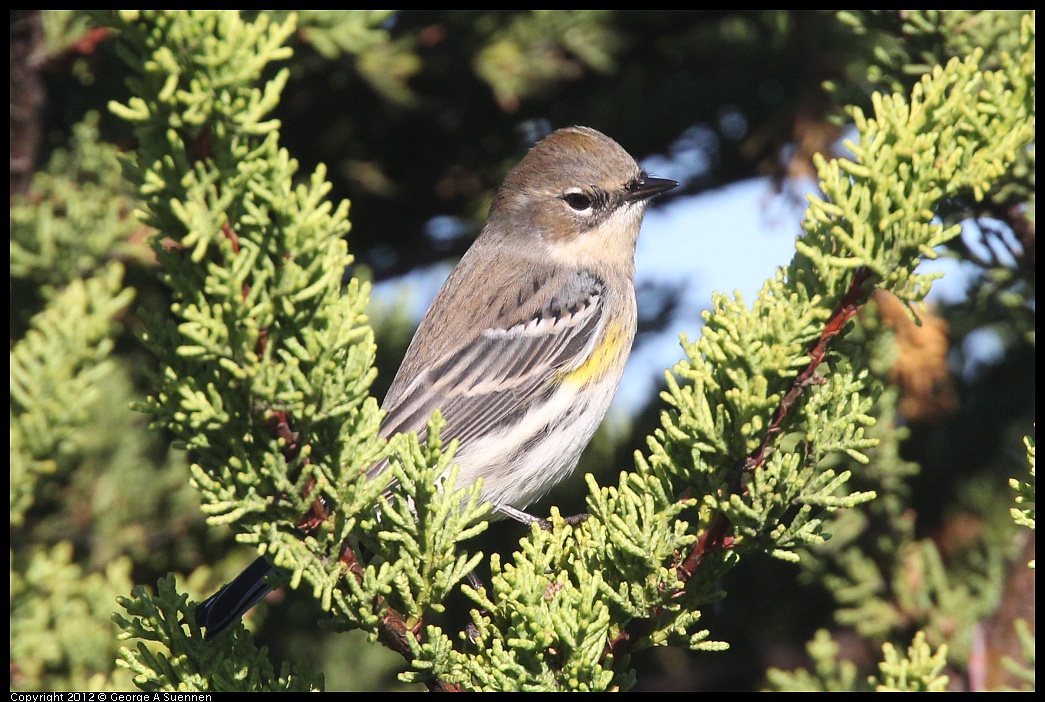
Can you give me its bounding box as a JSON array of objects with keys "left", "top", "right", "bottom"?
[{"left": 9, "top": 107, "right": 141, "bottom": 691}]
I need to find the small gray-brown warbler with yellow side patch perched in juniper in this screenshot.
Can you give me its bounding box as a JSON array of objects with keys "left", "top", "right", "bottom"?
[{"left": 196, "top": 126, "right": 678, "bottom": 637}]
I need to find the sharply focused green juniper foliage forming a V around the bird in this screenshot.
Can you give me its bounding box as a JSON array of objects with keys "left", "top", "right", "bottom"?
[{"left": 101, "top": 13, "right": 1034, "bottom": 689}]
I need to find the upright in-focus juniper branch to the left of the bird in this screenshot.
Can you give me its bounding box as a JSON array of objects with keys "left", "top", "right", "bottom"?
[{"left": 106, "top": 13, "right": 392, "bottom": 635}]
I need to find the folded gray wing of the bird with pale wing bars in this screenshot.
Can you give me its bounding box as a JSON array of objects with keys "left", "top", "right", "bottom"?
[{"left": 370, "top": 271, "right": 606, "bottom": 475}]
